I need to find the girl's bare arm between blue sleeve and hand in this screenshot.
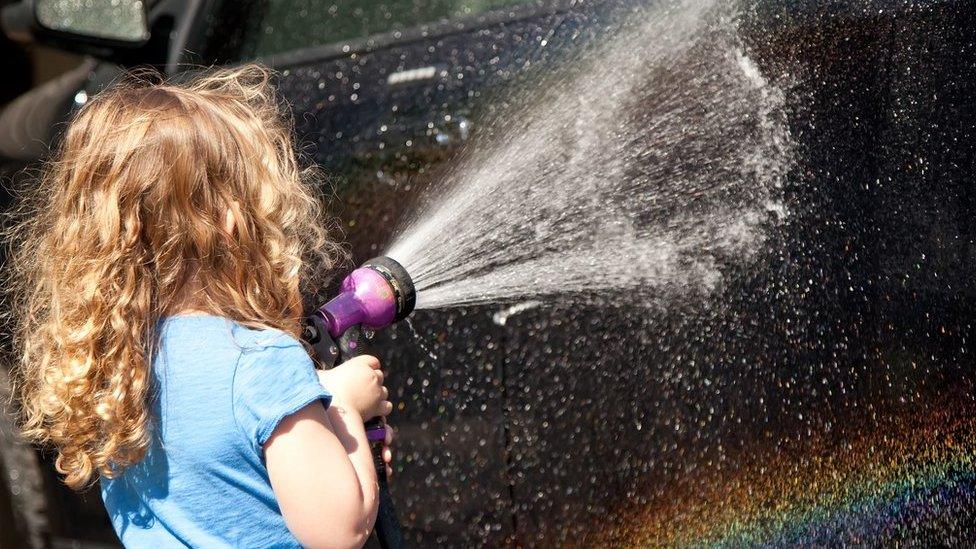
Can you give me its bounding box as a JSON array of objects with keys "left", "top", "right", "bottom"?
[{"left": 265, "top": 402, "right": 377, "bottom": 548}]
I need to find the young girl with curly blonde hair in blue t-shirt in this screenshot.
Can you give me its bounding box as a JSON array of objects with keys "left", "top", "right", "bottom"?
[{"left": 14, "top": 66, "right": 392, "bottom": 547}]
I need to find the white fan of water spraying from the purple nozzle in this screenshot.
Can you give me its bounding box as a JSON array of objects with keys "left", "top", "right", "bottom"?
[{"left": 387, "top": 1, "right": 791, "bottom": 308}]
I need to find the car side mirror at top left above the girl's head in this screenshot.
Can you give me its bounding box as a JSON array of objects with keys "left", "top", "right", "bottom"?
[{"left": 0, "top": 0, "right": 149, "bottom": 58}]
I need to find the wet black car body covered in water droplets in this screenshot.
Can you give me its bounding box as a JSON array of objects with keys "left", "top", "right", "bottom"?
[{"left": 0, "top": 1, "right": 976, "bottom": 546}]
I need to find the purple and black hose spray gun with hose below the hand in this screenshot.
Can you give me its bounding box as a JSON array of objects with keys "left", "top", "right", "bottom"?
[{"left": 303, "top": 257, "right": 417, "bottom": 548}]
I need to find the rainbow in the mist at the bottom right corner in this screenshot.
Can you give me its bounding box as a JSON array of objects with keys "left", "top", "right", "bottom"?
[{"left": 587, "top": 403, "right": 976, "bottom": 547}]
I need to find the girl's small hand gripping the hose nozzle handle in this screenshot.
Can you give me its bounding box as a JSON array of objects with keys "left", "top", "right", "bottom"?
[{"left": 318, "top": 355, "right": 393, "bottom": 420}]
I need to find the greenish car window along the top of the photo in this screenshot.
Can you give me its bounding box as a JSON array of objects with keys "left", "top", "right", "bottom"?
[{"left": 234, "top": 0, "right": 526, "bottom": 58}]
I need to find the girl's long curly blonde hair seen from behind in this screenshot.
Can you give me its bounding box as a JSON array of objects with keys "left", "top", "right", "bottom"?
[{"left": 6, "top": 65, "right": 336, "bottom": 489}]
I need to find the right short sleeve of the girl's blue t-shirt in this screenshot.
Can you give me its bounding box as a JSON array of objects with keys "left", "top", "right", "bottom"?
[{"left": 233, "top": 333, "right": 332, "bottom": 454}]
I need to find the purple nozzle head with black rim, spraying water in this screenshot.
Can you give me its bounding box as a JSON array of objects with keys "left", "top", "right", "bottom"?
[{"left": 317, "top": 257, "right": 417, "bottom": 338}]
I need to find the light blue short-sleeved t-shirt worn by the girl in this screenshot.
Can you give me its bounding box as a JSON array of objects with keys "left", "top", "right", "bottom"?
[{"left": 101, "top": 316, "right": 331, "bottom": 547}]
